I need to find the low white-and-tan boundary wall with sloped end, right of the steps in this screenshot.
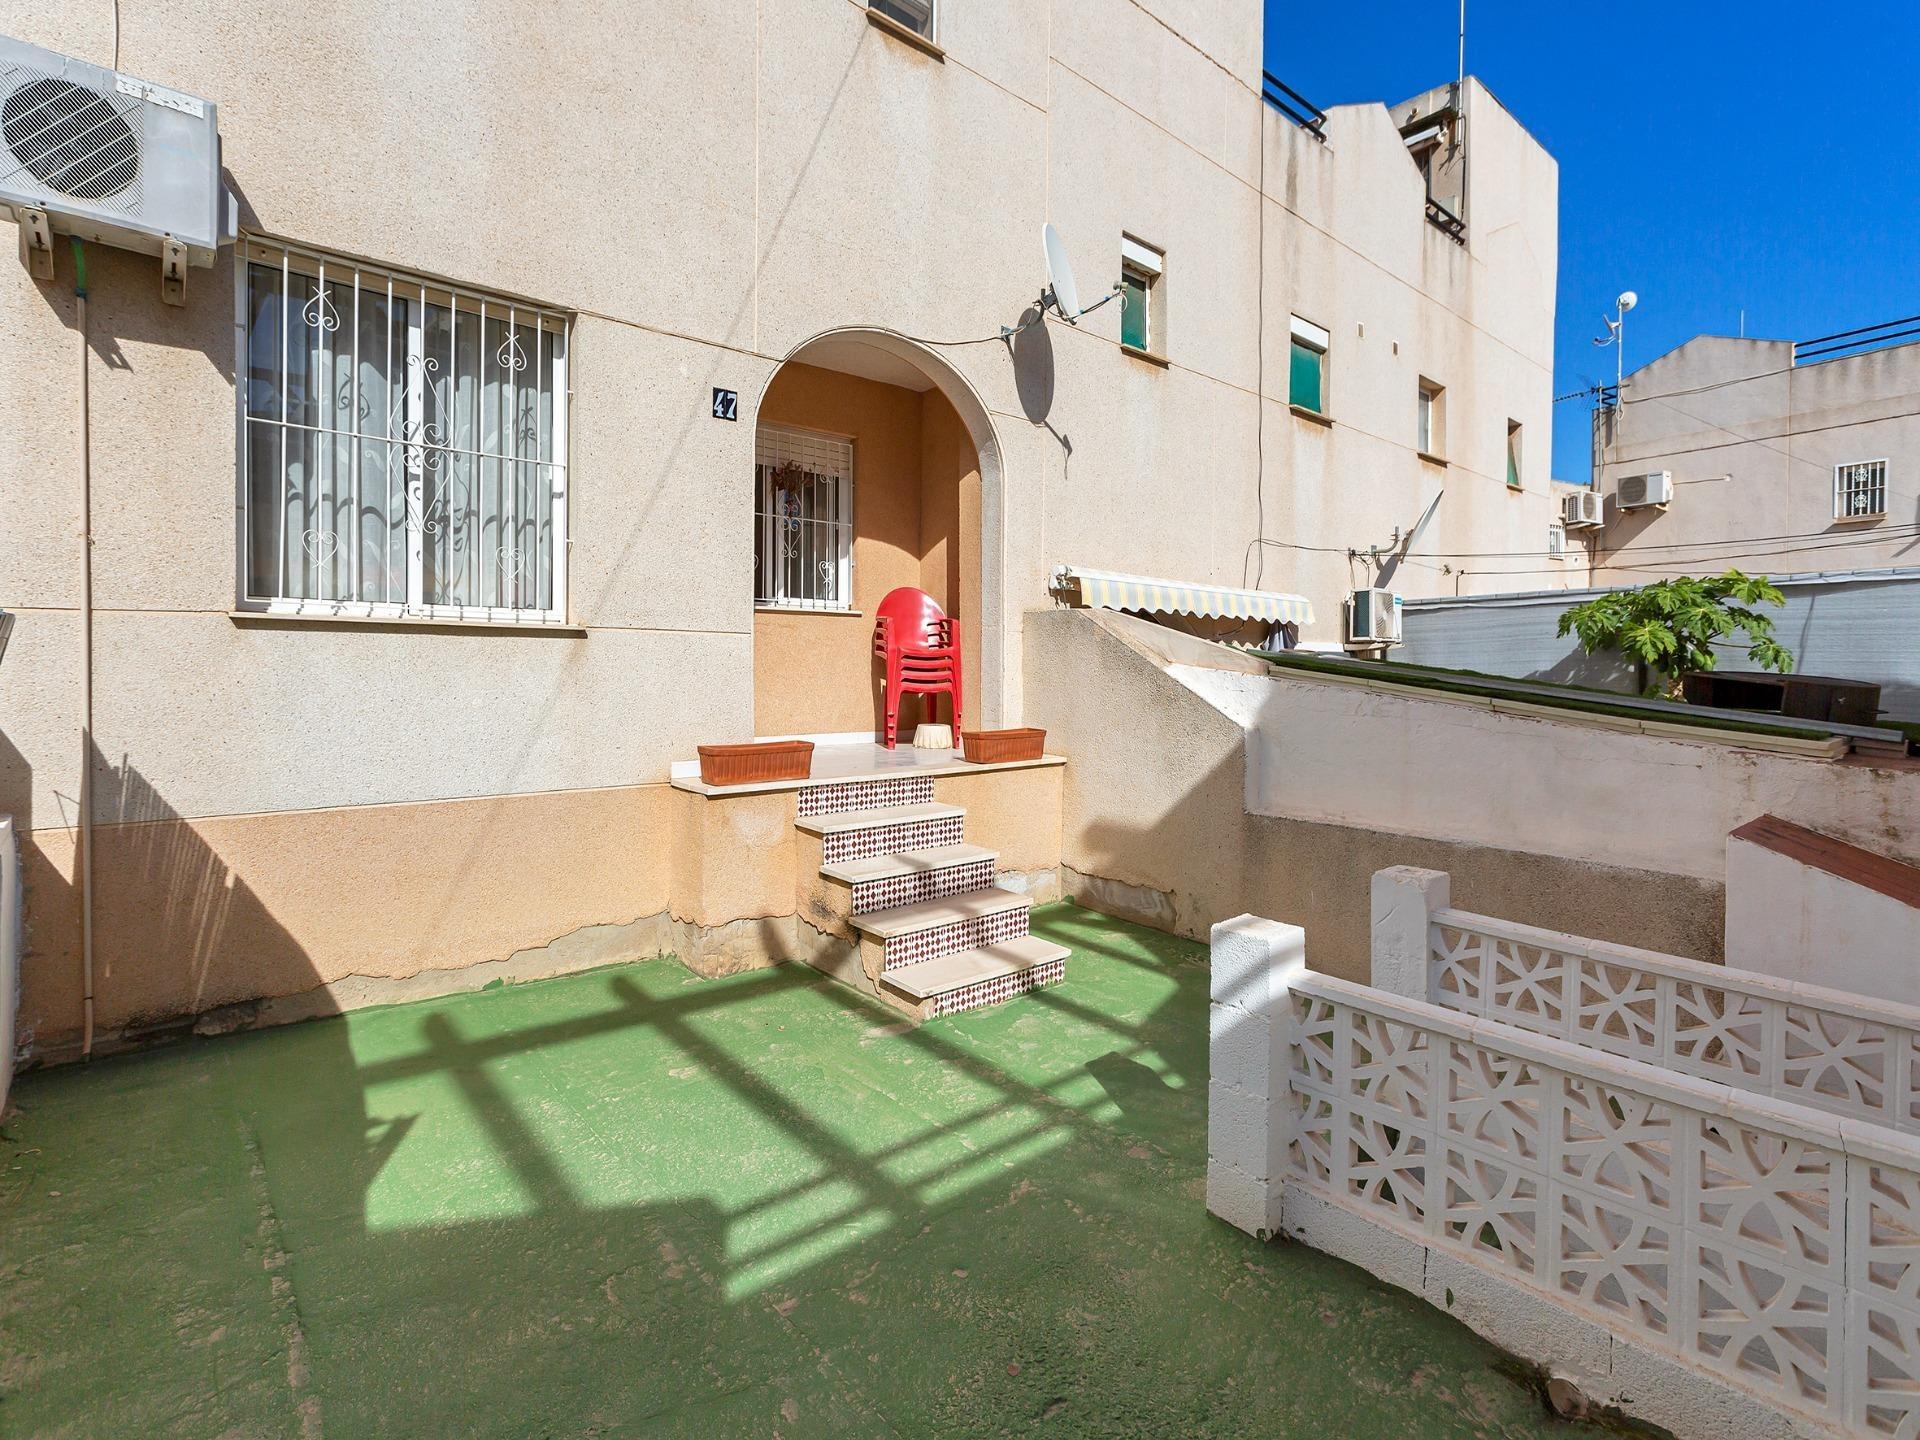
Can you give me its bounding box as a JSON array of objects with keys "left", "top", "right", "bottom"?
[{"left": 1027, "top": 611, "right": 1920, "bottom": 979}]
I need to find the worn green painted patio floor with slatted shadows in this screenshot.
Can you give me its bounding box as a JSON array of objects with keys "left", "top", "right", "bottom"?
[{"left": 0, "top": 906, "right": 1557, "bottom": 1440}]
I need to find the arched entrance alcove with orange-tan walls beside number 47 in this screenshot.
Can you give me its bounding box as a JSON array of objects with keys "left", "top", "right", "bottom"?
[{"left": 753, "top": 328, "right": 1002, "bottom": 735}]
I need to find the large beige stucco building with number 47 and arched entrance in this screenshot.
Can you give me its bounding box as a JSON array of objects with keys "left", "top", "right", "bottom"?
[{"left": 0, "top": 0, "right": 1566, "bottom": 1054}]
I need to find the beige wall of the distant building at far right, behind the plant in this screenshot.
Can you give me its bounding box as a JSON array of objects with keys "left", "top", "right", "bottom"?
[{"left": 1594, "top": 336, "right": 1920, "bottom": 586}]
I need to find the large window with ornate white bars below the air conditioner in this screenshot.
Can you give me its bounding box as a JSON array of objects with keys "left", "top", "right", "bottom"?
[{"left": 236, "top": 238, "right": 566, "bottom": 622}]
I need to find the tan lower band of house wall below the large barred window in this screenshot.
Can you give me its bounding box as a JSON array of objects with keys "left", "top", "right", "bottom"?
[{"left": 19, "top": 772, "right": 674, "bottom": 1056}]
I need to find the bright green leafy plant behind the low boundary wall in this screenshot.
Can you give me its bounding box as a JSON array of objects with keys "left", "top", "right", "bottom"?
[{"left": 1559, "top": 570, "right": 1793, "bottom": 695}]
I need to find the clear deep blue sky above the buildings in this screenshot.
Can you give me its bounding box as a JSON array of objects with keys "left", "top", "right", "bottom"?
[{"left": 1265, "top": 0, "right": 1920, "bottom": 480}]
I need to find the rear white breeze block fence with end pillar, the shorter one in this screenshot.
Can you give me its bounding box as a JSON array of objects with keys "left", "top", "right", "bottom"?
[{"left": 1373, "top": 868, "right": 1920, "bottom": 1135}]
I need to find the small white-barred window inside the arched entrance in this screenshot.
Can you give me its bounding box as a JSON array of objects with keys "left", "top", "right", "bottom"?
[{"left": 753, "top": 424, "right": 852, "bottom": 611}]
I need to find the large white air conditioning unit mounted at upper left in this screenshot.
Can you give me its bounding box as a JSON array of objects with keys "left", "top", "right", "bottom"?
[{"left": 0, "top": 36, "right": 236, "bottom": 305}]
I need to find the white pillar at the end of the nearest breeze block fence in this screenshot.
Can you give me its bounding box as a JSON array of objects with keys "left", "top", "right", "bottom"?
[{"left": 1206, "top": 916, "right": 1308, "bottom": 1238}]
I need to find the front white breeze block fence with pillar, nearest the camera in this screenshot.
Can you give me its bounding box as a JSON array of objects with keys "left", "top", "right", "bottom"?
[{"left": 1208, "top": 872, "right": 1920, "bottom": 1436}]
